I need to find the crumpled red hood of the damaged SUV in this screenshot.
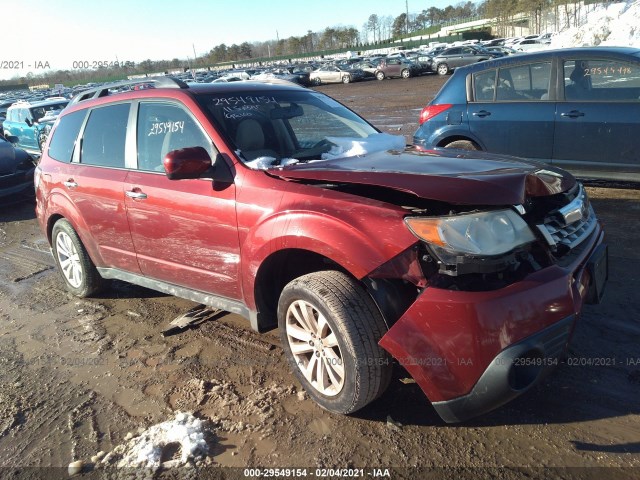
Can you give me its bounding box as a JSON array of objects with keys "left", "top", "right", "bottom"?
[{"left": 269, "top": 147, "right": 576, "bottom": 205}]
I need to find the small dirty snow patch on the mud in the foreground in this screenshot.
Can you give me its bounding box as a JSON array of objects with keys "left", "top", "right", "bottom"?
[{"left": 101, "top": 412, "right": 208, "bottom": 470}]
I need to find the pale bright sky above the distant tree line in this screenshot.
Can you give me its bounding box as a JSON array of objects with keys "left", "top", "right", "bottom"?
[{"left": 0, "top": 0, "right": 458, "bottom": 79}]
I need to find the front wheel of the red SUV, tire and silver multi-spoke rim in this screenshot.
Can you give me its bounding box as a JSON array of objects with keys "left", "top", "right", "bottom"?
[{"left": 278, "top": 271, "right": 392, "bottom": 414}]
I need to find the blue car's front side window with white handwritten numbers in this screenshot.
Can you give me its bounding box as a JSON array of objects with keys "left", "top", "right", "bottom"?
[{"left": 564, "top": 60, "right": 640, "bottom": 102}]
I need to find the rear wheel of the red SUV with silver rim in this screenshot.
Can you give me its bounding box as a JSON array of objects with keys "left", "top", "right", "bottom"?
[{"left": 51, "top": 218, "right": 104, "bottom": 298}]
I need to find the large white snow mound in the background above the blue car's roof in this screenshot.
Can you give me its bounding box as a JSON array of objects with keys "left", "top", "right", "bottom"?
[{"left": 551, "top": 0, "right": 640, "bottom": 48}]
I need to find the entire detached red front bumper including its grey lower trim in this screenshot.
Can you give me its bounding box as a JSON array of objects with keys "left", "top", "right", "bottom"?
[{"left": 379, "top": 228, "right": 607, "bottom": 422}]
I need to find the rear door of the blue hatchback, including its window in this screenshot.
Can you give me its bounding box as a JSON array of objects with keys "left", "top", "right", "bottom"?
[{"left": 467, "top": 61, "right": 555, "bottom": 161}]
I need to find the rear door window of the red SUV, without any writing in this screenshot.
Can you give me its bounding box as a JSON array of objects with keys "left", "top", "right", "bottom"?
[{"left": 80, "top": 103, "right": 129, "bottom": 168}]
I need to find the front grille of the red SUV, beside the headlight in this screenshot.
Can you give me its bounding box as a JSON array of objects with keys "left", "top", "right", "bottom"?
[{"left": 536, "top": 185, "right": 597, "bottom": 251}]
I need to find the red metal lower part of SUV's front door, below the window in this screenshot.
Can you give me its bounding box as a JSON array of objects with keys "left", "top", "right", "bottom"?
[{"left": 124, "top": 170, "right": 242, "bottom": 300}]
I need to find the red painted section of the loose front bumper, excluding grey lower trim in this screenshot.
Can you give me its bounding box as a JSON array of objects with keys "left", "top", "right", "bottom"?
[{"left": 379, "top": 229, "right": 603, "bottom": 402}]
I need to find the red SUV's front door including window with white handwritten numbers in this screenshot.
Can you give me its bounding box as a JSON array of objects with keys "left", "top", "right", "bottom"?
[{"left": 125, "top": 101, "right": 241, "bottom": 299}]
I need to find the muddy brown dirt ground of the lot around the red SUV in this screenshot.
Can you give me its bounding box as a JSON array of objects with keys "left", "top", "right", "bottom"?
[{"left": 0, "top": 76, "right": 640, "bottom": 479}]
